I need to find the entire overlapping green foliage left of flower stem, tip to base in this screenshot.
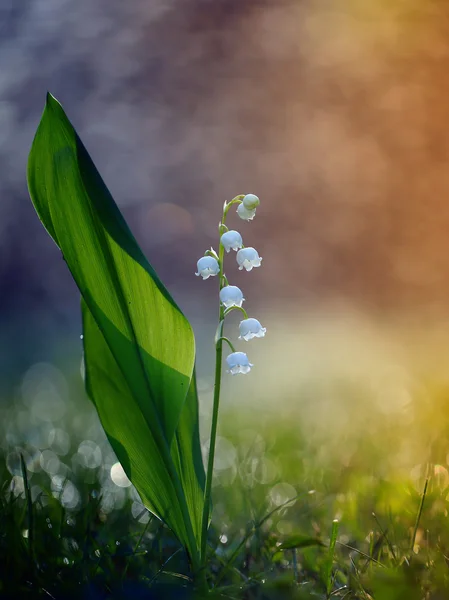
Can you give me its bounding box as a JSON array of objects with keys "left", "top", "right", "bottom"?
[{"left": 28, "top": 94, "right": 204, "bottom": 560}]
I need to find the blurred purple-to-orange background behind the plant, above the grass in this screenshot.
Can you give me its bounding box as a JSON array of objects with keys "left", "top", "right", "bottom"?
[{"left": 0, "top": 0, "right": 449, "bottom": 528}]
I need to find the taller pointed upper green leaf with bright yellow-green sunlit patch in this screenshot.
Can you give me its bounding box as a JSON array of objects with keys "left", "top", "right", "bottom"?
[{"left": 28, "top": 95, "right": 195, "bottom": 443}]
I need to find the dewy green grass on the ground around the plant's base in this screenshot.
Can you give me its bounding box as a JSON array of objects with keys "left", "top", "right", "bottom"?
[{"left": 0, "top": 380, "right": 449, "bottom": 600}]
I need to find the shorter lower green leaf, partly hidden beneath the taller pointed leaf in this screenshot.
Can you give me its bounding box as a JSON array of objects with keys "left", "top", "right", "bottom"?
[{"left": 82, "top": 301, "right": 204, "bottom": 547}]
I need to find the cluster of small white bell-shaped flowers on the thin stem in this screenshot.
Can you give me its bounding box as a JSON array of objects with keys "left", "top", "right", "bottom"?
[{"left": 195, "top": 194, "right": 266, "bottom": 375}]
